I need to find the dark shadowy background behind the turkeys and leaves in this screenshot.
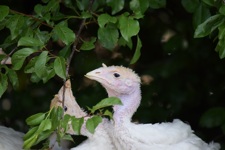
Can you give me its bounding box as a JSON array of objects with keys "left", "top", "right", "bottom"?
[{"left": 0, "top": 0, "right": 225, "bottom": 149}]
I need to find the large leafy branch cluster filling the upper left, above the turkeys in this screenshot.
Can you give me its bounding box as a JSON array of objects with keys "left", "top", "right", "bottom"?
[{"left": 0, "top": 0, "right": 166, "bottom": 96}]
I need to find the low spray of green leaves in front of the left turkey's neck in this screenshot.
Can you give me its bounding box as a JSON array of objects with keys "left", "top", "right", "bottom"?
[{"left": 23, "top": 97, "right": 122, "bottom": 149}]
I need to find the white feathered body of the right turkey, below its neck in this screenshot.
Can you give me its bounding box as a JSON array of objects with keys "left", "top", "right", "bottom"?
[{"left": 112, "top": 119, "right": 220, "bottom": 150}]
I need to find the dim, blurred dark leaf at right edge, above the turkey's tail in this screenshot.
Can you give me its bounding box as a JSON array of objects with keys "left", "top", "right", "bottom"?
[{"left": 199, "top": 107, "right": 225, "bottom": 128}]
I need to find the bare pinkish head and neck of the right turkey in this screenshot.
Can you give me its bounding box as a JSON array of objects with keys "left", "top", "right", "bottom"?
[{"left": 85, "top": 64, "right": 141, "bottom": 122}]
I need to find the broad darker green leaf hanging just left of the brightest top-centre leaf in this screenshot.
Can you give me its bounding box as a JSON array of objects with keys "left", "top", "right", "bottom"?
[{"left": 98, "top": 25, "right": 119, "bottom": 50}]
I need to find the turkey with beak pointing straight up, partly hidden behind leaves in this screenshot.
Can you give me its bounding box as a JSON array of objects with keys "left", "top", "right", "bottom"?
[{"left": 50, "top": 80, "right": 115, "bottom": 150}]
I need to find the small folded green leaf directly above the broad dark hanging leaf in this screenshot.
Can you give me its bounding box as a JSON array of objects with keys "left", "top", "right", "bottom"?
[{"left": 98, "top": 14, "right": 117, "bottom": 28}]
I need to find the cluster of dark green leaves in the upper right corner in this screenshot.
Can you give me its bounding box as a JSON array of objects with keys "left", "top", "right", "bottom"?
[{"left": 182, "top": 0, "right": 225, "bottom": 59}]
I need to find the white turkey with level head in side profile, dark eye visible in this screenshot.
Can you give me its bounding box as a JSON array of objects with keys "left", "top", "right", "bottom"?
[{"left": 85, "top": 65, "right": 220, "bottom": 150}]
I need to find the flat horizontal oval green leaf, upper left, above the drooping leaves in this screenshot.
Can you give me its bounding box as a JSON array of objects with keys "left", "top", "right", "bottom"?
[{"left": 17, "top": 37, "right": 44, "bottom": 46}]
